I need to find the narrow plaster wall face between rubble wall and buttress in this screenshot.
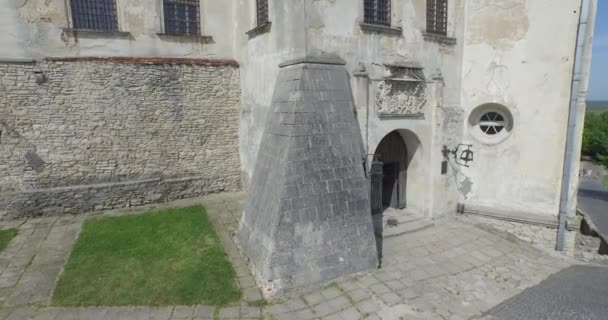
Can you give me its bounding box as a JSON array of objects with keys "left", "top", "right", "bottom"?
[{"left": 233, "top": 0, "right": 306, "bottom": 185}]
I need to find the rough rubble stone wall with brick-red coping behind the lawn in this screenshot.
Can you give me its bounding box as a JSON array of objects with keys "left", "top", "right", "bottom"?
[{"left": 0, "top": 59, "right": 240, "bottom": 217}]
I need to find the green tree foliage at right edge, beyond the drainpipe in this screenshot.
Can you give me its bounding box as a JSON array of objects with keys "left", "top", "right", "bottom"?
[{"left": 582, "top": 112, "right": 608, "bottom": 168}]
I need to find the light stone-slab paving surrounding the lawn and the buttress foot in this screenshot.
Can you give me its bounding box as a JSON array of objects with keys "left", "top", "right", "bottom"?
[{"left": 0, "top": 194, "right": 574, "bottom": 320}]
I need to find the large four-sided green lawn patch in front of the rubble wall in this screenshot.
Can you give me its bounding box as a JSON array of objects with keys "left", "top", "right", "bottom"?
[{"left": 53, "top": 206, "right": 241, "bottom": 306}]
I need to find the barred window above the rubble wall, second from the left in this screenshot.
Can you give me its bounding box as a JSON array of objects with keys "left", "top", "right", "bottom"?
[{"left": 163, "top": 0, "right": 200, "bottom": 34}]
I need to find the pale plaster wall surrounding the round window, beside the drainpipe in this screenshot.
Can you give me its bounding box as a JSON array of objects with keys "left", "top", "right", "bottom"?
[{"left": 460, "top": 0, "right": 580, "bottom": 218}]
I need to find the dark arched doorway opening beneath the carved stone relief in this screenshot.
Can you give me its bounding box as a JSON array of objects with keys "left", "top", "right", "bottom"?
[{"left": 375, "top": 131, "right": 408, "bottom": 209}]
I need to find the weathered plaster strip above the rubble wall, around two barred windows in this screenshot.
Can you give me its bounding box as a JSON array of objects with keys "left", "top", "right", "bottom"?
[{"left": 0, "top": 0, "right": 234, "bottom": 59}]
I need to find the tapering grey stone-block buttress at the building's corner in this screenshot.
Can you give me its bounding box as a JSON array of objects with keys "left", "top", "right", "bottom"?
[{"left": 240, "top": 55, "right": 377, "bottom": 296}]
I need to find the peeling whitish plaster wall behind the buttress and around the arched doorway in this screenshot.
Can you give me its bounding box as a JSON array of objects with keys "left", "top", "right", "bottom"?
[{"left": 241, "top": 0, "right": 464, "bottom": 216}]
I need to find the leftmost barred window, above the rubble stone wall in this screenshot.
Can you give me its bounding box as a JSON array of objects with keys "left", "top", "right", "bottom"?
[{"left": 70, "top": 0, "right": 118, "bottom": 31}]
